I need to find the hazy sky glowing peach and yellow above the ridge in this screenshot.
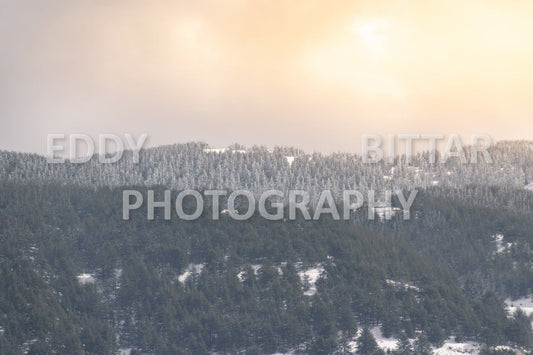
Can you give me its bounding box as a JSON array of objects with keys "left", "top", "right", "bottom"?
[{"left": 0, "top": 0, "right": 533, "bottom": 154}]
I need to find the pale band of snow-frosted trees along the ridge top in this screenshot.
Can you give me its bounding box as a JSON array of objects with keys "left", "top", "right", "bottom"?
[{"left": 0, "top": 141, "right": 533, "bottom": 206}]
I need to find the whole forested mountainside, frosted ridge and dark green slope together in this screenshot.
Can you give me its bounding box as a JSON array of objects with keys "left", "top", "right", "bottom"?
[{"left": 0, "top": 142, "right": 533, "bottom": 354}]
